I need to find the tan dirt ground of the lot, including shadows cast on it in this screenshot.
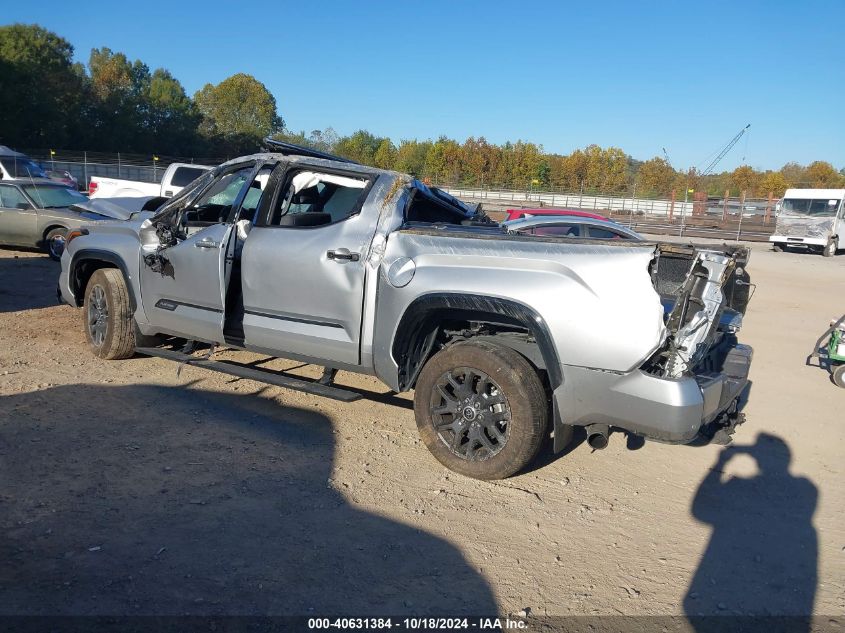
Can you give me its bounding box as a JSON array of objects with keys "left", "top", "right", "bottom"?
[{"left": 0, "top": 244, "right": 845, "bottom": 615}]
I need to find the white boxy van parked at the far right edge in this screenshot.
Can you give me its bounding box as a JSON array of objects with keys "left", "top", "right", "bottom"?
[{"left": 769, "top": 189, "right": 845, "bottom": 257}]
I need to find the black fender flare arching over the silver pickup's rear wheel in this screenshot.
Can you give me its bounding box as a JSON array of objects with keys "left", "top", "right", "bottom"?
[{"left": 391, "top": 292, "right": 563, "bottom": 391}]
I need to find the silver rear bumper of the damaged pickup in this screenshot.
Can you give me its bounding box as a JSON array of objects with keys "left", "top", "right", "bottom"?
[{"left": 554, "top": 345, "right": 753, "bottom": 448}]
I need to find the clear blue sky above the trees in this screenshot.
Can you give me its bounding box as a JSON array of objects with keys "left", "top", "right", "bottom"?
[{"left": 0, "top": 0, "right": 845, "bottom": 169}]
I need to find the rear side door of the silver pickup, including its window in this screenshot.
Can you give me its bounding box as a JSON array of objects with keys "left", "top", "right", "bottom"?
[{"left": 241, "top": 163, "right": 378, "bottom": 365}]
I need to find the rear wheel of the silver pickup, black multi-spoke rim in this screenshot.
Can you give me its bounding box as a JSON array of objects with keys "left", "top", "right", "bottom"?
[{"left": 414, "top": 341, "right": 549, "bottom": 479}]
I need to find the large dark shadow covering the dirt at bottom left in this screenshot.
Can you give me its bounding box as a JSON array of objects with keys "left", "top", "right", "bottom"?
[{"left": 0, "top": 385, "right": 497, "bottom": 616}]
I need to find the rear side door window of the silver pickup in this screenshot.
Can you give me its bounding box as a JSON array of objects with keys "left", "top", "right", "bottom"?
[{"left": 269, "top": 170, "right": 369, "bottom": 227}]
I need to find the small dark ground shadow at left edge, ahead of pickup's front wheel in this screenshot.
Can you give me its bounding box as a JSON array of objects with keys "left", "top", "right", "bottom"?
[{"left": 0, "top": 248, "right": 59, "bottom": 312}]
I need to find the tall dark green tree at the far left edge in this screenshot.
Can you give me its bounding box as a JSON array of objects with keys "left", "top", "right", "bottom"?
[{"left": 0, "top": 24, "right": 84, "bottom": 147}]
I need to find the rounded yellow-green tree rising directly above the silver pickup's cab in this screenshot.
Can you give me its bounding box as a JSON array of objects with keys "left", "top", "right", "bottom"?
[{"left": 194, "top": 73, "right": 284, "bottom": 152}]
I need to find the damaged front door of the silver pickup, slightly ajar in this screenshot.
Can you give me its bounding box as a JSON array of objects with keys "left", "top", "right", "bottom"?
[{"left": 140, "top": 162, "right": 256, "bottom": 342}]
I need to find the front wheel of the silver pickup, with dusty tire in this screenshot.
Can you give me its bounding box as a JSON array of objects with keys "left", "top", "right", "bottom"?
[{"left": 82, "top": 268, "right": 135, "bottom": 360}]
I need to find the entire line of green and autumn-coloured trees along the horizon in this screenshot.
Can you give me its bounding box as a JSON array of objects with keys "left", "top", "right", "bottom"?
[{"left": 0, "top": 24, "right": 845, "bottom": 197}]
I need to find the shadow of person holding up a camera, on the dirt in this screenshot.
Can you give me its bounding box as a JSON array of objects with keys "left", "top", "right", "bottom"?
[{"left": 684, "top": 433, "right": 818, "bottom": 631}]
